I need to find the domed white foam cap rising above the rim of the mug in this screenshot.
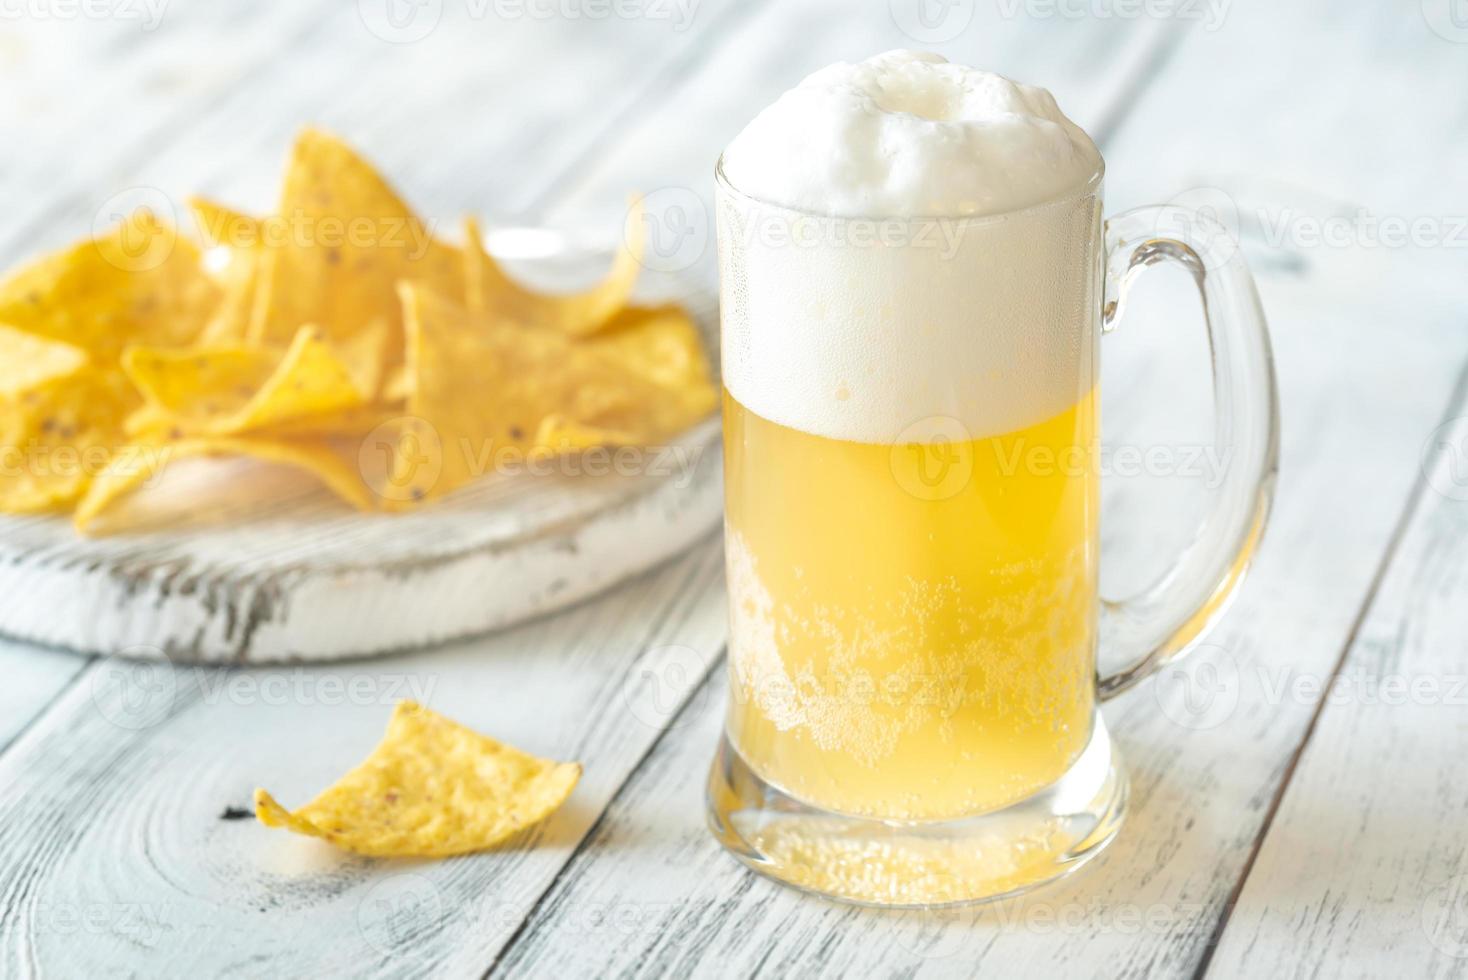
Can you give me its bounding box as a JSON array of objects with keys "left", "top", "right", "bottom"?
[{"left": 724, "top": 51, "right": 1101, "bottom": 217}]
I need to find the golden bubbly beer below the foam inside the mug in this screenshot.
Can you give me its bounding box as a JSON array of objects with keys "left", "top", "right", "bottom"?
[{"left": 724, "top": 390, "right": 1098, "bottom": 820}]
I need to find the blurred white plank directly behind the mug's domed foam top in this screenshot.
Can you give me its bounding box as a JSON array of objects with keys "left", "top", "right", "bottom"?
[{"left": 546, "top": 0, "right": 1180, "bottom": 234}]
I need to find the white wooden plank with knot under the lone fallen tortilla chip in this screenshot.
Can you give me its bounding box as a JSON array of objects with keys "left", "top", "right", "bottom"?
[{"left": 0, "top": 540, "right": 724, "bottom": 977}]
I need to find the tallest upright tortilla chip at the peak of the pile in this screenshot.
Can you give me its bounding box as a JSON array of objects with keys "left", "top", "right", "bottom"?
[{"left": 250, "top": 129, "right": 464, "bottom": 368}]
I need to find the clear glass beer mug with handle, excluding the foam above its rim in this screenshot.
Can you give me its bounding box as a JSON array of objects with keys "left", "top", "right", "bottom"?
[{"left": 708, "top": 61, "right": 1277, "bottom": 907}]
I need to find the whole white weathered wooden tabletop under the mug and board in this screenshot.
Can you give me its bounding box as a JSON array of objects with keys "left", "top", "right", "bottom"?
[{"left": 0, "top": 0, "right": 1468, "bottom": 977}]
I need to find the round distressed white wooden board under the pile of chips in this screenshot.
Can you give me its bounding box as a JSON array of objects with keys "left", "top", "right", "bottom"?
[{"left": 0, "top": 242, "right": 722, "bottom": 663}]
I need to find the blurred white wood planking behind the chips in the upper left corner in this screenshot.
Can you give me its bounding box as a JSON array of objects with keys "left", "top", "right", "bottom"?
[{"left": 0, "top": 0, "right": 759, "bottom": 264}]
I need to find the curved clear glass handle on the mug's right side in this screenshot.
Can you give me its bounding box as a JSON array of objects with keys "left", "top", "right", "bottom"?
[{"left": 1097, "top": 205, "right": 1279, "bottom": 700}]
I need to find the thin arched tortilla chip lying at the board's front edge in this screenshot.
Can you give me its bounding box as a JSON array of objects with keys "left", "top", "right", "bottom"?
[{"left": 72, "top": 437, "right": 373, "bottom": 533}]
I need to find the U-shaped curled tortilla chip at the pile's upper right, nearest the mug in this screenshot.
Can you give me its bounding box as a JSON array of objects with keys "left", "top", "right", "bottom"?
[{"left": 464, "top": 198, "right": 646, "bottom": 336}]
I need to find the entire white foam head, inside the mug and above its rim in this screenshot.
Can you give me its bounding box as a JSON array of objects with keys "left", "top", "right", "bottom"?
[{"left": 718, "top": 51, "right": 1101, "bottom": 443}]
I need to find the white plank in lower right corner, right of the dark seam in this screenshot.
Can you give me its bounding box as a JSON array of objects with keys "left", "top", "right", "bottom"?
[{"left": 1213, "top": 381, "right": 1468, "bottom": 977}]
